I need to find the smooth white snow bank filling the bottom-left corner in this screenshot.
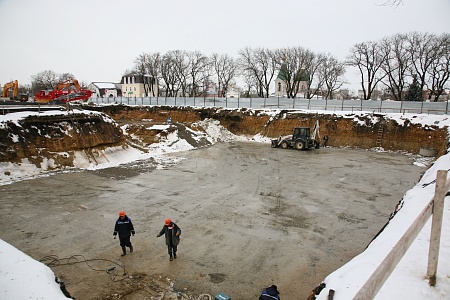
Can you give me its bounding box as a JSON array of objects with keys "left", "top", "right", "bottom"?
[{"left": 0, "top": 240, "right": 70, "bottom": 300}]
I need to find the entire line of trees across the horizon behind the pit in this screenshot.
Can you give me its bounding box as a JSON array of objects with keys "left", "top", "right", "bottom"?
[{"left": 32, "top": 32, "right": 450, "bottom": 101}]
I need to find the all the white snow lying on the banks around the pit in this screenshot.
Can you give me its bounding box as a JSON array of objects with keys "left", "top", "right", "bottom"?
[{"left": 0, "top": 106, "right": 450, "bottom": 300}]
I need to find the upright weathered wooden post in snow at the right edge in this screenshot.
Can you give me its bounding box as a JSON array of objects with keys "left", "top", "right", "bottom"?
[{"left": 427, "top": 170, "right": 448, "bottom": 286}]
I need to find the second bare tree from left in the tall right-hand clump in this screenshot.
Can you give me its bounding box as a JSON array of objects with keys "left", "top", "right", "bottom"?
[{"left": 381, "top": 34, "right": 411, "bottom": 101}]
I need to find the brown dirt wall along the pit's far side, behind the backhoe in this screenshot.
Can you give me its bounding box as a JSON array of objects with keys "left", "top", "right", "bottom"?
[{"left": 92, "top": 106, "right": 448, "bottom": 156}]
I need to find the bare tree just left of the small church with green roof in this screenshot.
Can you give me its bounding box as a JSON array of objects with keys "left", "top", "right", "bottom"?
[{"left": 238, "top": 47, "right": 279, "bottom": 97}]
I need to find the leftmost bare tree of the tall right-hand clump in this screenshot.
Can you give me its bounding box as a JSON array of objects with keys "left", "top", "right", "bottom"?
[{"left": 346, "top": 42, "right": 386, "bottom": 100}]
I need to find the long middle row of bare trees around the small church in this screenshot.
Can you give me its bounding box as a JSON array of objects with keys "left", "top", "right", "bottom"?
[{"left": 134, "top": 47, "right": 345, "bottom": 98}]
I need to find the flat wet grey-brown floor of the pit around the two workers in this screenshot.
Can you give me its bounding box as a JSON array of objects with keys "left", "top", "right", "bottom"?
[{"left": 0, "top": 142, "right": 424, "bottom": 299}]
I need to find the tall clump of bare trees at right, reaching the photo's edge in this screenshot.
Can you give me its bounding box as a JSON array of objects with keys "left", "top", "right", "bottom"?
[{"left": 346, "top": 32, "right": 450, "bottom": 101}]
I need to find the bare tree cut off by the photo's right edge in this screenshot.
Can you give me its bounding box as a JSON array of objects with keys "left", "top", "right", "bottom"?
[{"left": 428, "top": 33, "right": 450, "bottom": 101}]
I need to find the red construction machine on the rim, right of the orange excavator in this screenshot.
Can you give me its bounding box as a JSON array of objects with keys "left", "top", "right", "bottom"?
[{"left": 34, "top": 78, "right": 92, "bottom": 103}]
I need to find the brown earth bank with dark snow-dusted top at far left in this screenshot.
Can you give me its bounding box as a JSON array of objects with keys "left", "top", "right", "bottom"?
[{"left": 0, "top": 114, "right": 125, "bottom": 166}]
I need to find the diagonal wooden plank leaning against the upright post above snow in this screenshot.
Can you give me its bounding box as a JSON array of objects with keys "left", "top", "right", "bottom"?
[{"left": 353, "top": 198, "right": 434, "bottom": 300}]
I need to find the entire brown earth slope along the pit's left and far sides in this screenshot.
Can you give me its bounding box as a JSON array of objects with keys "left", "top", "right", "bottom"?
[{"left": 0, "top": 105, "right": 448, "bottom": 167}]
